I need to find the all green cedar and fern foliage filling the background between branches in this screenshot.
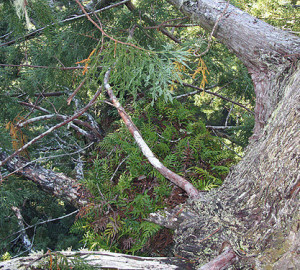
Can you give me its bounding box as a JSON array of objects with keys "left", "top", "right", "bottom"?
[{"left": 5, "top": 0, "right": 299, "bottom": 258}]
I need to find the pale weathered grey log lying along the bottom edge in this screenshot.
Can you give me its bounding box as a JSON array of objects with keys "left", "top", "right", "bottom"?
[{"left": 0, "top": 251, "right": 193, "bottom": 270}]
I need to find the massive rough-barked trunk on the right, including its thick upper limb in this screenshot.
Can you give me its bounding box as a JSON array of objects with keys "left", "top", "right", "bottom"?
[{"left": 162, "top": 0, "right": 300, "bottom": 269}]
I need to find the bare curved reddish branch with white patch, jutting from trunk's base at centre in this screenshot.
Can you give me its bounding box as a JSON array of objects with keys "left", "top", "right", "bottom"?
[{"left": 104, "top": 69, "right": 203, "bottom": 199}]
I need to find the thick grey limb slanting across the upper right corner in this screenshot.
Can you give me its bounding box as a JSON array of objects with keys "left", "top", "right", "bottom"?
[{"left": 167, "top": 0, "right": 300, "bottom": 70}]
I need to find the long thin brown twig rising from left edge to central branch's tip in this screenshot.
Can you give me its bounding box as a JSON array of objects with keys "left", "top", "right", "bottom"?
[{"left": 0, "top": 87, "right": 102, "bottom": 167}]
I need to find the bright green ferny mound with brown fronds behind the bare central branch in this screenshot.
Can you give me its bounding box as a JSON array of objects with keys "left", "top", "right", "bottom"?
[{"left": 72, "top": 98, "right": 239, "bottom": 254}]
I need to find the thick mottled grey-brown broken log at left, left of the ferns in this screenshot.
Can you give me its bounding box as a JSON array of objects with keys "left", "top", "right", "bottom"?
[{"left": 0, "top": 148, "right": 92, "bottom": 208}]
